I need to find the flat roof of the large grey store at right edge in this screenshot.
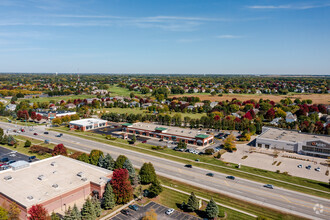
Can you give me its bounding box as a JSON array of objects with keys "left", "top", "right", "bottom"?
[{"left": 259, "top": 127, "right": 330, "bottom": 143}]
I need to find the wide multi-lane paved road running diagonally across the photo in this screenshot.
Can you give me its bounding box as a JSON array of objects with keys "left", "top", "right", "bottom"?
[{"left": 0, "top": 122, "right": 330, "bottom": 219}]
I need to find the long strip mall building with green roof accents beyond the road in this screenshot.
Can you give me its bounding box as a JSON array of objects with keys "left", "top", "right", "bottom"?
[{"left": 122, "top": 122, "right": 214, "bottom": 146}]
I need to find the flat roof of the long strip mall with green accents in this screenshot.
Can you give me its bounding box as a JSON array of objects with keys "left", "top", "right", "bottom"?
[{"left": 128, "top": 122, "right": 210, "bottom": 138}]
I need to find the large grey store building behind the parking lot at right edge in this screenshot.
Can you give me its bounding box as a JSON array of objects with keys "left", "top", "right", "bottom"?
[{"left": 256, "top": 127, "right": 330, "bottom": 158}]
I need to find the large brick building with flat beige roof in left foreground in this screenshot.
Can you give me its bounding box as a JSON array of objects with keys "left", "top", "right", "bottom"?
[{"left": 0, "top": 156, "right": 112, "bottom": 219}]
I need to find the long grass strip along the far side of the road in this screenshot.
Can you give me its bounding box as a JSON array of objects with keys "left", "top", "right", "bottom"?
[{"left": 51, "top": 127, "right": 330, "bottom": 199}]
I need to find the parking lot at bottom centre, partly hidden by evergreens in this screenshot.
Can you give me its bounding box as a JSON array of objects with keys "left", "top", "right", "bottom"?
[{"left": 111, "top": 202, "right": 200, "bottom": 220}]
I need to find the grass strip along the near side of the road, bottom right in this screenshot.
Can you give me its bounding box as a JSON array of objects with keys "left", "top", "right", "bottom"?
[{"left": 158, "top": 176, "right": 303, "bottom": 220}]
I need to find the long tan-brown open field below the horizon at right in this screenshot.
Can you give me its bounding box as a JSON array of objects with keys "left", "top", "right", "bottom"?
[{"left": 171, "top": 93, "right": 330, "bottom": 104}]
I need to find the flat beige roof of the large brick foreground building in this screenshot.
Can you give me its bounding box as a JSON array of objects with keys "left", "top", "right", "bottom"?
[{"left": 0, "top": 156, "right": 112, "bottom": 208}]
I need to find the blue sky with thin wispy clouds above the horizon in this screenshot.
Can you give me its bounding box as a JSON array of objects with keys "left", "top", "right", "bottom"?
[{"left": 0, "top": 0, "right": 330, "bottom": 74}]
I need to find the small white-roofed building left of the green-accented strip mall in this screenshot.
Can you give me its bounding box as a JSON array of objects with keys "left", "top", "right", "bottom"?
[{"left": 70, "top": 118, "right": 108, "bottom": 131}]
